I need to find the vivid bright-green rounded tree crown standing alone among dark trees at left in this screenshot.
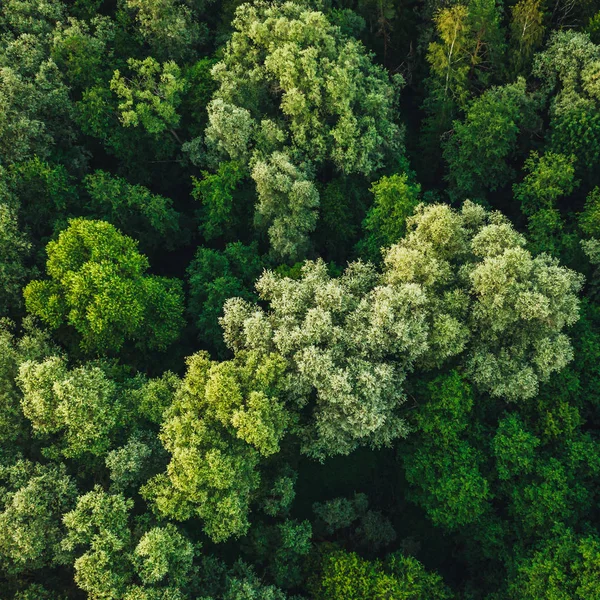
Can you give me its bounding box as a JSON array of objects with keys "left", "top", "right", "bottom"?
[{"left": 24, "top": 219, "right": 183, "bottom": 354}]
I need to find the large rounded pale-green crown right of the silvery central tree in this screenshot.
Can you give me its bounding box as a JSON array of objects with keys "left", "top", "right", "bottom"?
[{"left": 385, "top": 202, "right": 582, "bottom": 400}]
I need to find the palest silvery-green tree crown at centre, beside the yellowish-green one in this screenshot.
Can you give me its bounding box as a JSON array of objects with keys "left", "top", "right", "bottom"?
[{"left": 222, "top": 261, "right": 428, "bottom": 458}]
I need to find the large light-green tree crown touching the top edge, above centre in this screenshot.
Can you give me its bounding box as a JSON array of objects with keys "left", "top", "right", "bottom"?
[{"left": 209, "top": 2, "right": 400, "bottom": 174}]
